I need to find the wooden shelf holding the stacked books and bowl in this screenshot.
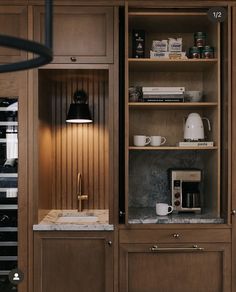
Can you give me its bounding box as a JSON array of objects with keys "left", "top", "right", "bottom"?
[{"left": 128, "top": 102, "right": 218, "bottom": 110}]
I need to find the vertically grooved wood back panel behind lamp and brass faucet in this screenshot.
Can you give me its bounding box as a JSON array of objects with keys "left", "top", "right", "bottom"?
[{"left": 41, "top": 70, "right": 109, "bottom": 209}]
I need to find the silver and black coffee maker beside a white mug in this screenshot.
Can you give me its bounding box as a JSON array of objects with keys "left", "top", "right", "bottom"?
[{"left": 170, "top": 169, "right": 202, "bottom": 213}]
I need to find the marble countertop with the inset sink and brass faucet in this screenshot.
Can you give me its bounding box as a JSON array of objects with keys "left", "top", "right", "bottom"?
[{"left": 33, "top": 210, "right": 114, "bottom": 231}]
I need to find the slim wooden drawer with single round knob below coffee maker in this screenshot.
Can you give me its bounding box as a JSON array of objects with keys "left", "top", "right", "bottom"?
[{"left": 119, "top": 229, "right": 231, "bottom": 243}]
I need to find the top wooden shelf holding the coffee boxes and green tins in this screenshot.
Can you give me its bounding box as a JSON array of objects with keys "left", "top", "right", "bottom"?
[{"left": 128, "top": 58, "right": 217, "bottom": 72}]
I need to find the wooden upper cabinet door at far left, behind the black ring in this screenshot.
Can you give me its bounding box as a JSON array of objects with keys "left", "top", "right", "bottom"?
[{"left": 0, "top": 6, "right": 27, "bottom": 63}]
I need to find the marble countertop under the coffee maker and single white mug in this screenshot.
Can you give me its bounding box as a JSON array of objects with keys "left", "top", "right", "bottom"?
[{"left": 128, "top": 208, "right": 224, "bottom": 224}]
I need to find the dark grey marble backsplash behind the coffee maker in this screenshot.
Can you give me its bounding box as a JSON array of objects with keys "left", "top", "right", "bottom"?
[{"left": 129, "top": 150, "right": 205, "bottom": 208}]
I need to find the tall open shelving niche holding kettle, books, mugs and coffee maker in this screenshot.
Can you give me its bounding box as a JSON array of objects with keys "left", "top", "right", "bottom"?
[{"left": 125, "top": 8, "right": 227, "bottom": 224}]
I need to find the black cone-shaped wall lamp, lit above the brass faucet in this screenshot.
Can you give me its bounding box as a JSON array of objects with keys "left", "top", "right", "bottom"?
[{"left": 66, "top": 90, "right": 92, "bottom": 124}]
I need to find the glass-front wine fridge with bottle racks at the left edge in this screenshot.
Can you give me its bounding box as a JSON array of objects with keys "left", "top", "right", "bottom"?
[{"left": 0, "top": 97, "right": 18, "bottom": 292}]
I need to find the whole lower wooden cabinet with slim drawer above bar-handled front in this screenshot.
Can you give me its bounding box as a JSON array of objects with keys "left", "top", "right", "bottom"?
[{"left": 119, "top": 227, "right": 231, "bottom": 292}]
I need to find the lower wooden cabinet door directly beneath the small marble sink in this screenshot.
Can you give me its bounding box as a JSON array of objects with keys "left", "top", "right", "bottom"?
[{"left": 34, "top": 232, "right": 113, "bottom": 292}]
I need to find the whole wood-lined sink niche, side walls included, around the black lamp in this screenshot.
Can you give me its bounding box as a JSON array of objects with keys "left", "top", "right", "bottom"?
[{"left": 35, "top": 64, "right": 113, "bottom": 222}]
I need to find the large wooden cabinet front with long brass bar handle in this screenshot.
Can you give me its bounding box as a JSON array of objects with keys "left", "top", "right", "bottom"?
[{"left": 120, "top": 244, "right": 230, "bottom": 292}]
